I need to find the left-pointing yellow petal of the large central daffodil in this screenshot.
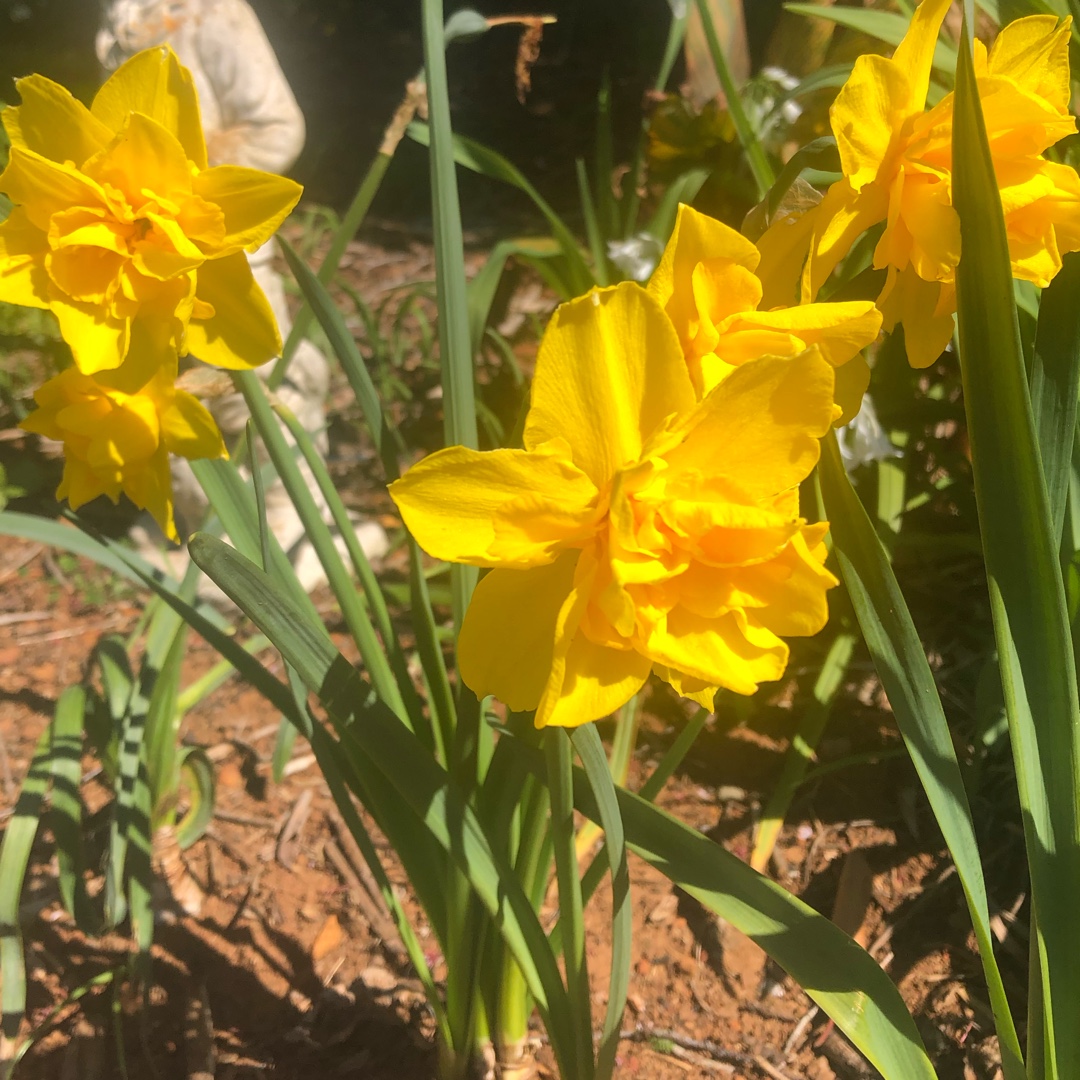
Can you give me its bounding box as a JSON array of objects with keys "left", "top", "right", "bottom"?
[{"left": 390, "top": 443, "right": 599, "bottom": 567}]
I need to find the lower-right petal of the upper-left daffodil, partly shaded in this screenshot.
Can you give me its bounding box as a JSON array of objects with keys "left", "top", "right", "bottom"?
[{"left": 186, "top": 252, "right": 281, "bottom": 370}]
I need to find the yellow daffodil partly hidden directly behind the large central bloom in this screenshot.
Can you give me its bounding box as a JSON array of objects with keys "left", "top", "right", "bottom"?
[{"left": 648, "top": 205, "right": 881, "bottom": 419}]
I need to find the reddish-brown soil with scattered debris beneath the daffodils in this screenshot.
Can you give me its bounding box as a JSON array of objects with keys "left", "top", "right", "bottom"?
[{"left": 0, "top": 230, "right": 1026, "bottom": 1080}]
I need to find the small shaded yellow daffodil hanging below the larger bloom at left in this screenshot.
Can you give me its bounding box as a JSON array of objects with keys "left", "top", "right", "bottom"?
[{"left": 21, "top": 366, "right": 226, "bottom": 540}]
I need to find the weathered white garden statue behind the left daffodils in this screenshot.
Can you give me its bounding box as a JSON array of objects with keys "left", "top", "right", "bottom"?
[{"left": 96, "top": 0, "right": 387, "bottom": 590}]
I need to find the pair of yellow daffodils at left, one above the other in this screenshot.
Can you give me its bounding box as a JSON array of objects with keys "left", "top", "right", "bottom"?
[{"left": 0, "top": 46, "right": 300, "bottom": 539}]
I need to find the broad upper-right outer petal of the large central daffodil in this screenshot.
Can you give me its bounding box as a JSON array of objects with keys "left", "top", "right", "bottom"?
[{"left": 665, "top": 349, "right": 834, "bottom": 501}]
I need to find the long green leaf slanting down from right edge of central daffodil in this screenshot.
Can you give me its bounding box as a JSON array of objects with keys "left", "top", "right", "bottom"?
[{"left": 819, "top": 433, "right": 1024, "bottom": 1080}]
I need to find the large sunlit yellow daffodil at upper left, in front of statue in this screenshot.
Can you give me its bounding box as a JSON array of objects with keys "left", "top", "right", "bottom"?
[{"left": 0, "top": 46, "right": 300, "bottom": 392}]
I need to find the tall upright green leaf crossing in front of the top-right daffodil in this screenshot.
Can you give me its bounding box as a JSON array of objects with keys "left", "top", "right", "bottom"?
[{"left": 953, "top": 10, "right": 1080, "bottom": 1080}]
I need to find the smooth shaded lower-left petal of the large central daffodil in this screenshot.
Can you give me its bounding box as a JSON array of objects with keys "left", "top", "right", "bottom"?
[{"left": 458, "top": 551, "right": 579, "bottom": 712}]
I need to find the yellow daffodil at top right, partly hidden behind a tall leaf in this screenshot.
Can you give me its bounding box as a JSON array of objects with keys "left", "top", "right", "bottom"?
[{"left": 804, "top": 0, "right": 1080, "bottom": 367}]
